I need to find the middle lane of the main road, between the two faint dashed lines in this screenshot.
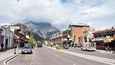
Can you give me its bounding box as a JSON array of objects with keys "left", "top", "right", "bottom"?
[{"left": 36, "top": 48, "right": 76, "bottom": 65}]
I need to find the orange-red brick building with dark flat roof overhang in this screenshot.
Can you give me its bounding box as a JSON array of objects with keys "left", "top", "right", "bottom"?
[{"left": 68, "top": 24, "right": 90, "bottom": 47}]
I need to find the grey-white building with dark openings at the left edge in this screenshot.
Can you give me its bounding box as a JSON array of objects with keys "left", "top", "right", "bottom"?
[{"left": 0, "top": 25, "right": 14, "bottom": 49}]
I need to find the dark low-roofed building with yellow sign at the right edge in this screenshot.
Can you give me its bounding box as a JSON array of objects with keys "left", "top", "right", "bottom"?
[{"left": 93, "top": 28, "right": 115, "bottom": 49}]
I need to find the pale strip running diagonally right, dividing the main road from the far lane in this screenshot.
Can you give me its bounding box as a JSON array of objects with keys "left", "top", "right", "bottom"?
[{"left": 48, "top": 47, "right": 115, "bottom": 65}]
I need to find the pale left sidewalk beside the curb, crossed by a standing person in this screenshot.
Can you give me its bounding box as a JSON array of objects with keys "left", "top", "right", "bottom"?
[{"left": 0, "top": 49, "right": 20, "bottom": 62}]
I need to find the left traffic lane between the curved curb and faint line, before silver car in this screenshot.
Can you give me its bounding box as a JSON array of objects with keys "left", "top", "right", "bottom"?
[{"left": 8, "top": 54, "right": 33, "bottom": 65}]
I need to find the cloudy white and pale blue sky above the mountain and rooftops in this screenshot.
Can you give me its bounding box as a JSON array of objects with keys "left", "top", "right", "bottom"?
[{"left": 0, "top": 0, "right": 115, "bottom": 30}]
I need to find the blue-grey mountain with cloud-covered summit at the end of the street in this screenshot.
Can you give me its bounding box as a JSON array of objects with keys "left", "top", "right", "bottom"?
[{"left": 25, "top": 21, "right": 59, "bottom": 38}]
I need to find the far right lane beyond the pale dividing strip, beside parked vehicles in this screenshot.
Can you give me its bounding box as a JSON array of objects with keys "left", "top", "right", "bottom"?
[{"left": 66, "top": 48, "right": 115, "bottom": 59}]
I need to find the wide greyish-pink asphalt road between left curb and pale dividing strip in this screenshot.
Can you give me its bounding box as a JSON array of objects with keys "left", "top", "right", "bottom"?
[{"left": 8, "top": 47, "right": 107, "bottom": 65}]
